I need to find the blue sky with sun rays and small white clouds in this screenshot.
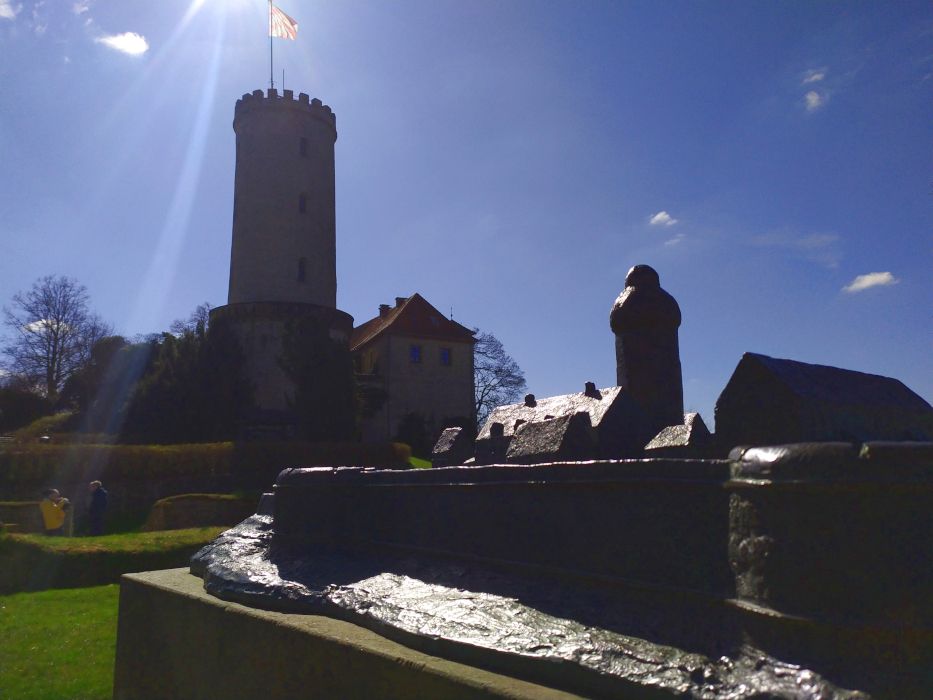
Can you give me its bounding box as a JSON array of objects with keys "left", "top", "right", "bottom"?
[{"left": 0, "top": 0, "right": 933, "bottom": 425}]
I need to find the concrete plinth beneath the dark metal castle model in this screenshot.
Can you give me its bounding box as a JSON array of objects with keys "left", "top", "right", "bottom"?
[{"left": 113, "top": 569, "right": 579, "bottom": 700}]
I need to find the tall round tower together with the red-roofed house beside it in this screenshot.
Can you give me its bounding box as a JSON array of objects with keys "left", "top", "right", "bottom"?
[{"left": 211, "top": 89, "right": 474, "bottom": 441}]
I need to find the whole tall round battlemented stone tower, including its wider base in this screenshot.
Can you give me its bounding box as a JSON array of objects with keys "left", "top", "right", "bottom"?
[{"left": 211, "top": 89, "right": 353, "bottom": 428}]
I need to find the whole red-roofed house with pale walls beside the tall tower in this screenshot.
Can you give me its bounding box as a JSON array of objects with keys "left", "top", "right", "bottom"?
[{"left": 350, "top": 294, "right": 476, "bottom": 441}]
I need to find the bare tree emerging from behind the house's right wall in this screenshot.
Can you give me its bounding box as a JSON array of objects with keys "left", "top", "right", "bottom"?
[{"left": 473, "top": 329, "right": 526, "bottom": 429}]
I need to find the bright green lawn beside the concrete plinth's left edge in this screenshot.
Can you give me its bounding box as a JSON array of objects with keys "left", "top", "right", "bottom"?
[{"left": 0, "top": 584, "right": 119, "bottom": 700}]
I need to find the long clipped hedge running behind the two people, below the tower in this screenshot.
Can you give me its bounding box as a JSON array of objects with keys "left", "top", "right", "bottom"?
[{"left": 0, "top": 442, "right": 411, "bottom": 493}]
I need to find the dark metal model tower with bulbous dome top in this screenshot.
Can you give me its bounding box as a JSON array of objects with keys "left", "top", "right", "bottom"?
[{"left": 609, "top": 265, "right": 684, "bottom": 434}]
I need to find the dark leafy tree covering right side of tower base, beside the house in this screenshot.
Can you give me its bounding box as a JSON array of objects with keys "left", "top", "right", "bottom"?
[{"left": 279, "top": 319, "right": 357, "bottom": 442}]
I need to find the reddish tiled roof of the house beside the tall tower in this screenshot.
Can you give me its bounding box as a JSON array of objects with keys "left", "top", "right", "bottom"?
[{"left": 350, "top": 292, "right": 476, "bottom": 351}]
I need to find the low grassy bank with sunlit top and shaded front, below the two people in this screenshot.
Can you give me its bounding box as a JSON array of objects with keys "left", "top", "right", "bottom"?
[{"left": 0, "top": 527, "right": 226, "bottom": 594}]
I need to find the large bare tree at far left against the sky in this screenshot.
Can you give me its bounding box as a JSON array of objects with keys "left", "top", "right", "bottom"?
[{"left": 3, "top": 275, "right": 113, "bottom": 400}]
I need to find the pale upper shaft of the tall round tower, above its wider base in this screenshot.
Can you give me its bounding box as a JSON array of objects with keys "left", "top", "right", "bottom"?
[{"left": 228, "top": 89, "right": 337, "bottom": 309}]
